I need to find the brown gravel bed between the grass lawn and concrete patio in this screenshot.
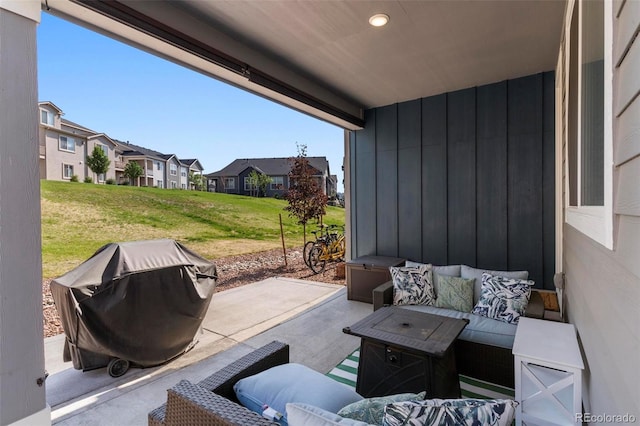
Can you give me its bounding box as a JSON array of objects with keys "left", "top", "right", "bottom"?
[{"left": 42, "top": 247, "right": 345, "bottom": 337}]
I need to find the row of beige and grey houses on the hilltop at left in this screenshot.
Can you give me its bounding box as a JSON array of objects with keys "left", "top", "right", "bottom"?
[{"left": 38, "top": 101, "right": 204, "bottom": 189}]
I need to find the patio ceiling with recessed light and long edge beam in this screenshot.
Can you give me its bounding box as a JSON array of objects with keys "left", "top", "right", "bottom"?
[{"left": 42, "top": 0, "right": 566, "bottom": 129}]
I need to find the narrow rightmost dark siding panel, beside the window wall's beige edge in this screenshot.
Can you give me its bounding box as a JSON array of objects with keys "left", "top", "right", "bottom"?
[{"left": 542, "top": 72, "right": 556, "bottom": 290}]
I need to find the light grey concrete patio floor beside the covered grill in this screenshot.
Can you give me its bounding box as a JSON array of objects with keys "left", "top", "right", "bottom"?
[{"left": 45, "top": 278, "right": 373, "bottom": 425}]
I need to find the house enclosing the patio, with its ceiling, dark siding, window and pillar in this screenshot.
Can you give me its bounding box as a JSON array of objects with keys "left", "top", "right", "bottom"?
[{"left": 0, "top": 0, "right": 640, "bottom": 423}]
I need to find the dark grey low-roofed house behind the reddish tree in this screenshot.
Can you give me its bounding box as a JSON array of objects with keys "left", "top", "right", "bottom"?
[{"left": 205, "top": 157, "right": 337, "bottom": 197}]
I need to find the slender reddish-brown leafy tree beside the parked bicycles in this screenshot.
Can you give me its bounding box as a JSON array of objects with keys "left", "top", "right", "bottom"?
[{"left": 284, "top": 145, "right": 327, "bottom": 243}]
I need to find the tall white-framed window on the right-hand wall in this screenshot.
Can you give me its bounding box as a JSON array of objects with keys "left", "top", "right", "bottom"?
[{"left": 558, "top": 0, "right": 613, "bottom": 248}]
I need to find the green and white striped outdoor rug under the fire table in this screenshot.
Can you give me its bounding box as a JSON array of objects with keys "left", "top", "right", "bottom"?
[{"left": 327, "top": 349, "right": 515, "bottom": 399}]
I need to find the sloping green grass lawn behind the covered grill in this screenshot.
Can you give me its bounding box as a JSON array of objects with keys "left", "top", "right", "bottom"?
[{"left": 40, "top": 180, "right": 345, "bottom": 279}]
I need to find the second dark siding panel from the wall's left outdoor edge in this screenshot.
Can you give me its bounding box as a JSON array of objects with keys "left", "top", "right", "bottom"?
[{"left": 376, "top": 104, "right": 398, "bottom": 256}]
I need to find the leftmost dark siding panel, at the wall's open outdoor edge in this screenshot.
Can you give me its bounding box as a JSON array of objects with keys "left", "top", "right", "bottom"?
[{"left": 352, "top": 110, "right": 376, "bottom": 257}]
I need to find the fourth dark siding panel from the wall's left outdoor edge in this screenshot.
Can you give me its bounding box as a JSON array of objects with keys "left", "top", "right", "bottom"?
[{"left": 421, "top": 95, "right": 449, "bottom": 265}]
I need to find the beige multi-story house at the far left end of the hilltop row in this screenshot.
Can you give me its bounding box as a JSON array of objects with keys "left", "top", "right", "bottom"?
[{"left": 38, "top": 101, "right": 116, "bottom": 182}]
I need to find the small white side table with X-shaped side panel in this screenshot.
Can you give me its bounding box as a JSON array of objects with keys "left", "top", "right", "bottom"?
[{"left": 513, "top": 317, "right": 584, "bottom": 426}]
